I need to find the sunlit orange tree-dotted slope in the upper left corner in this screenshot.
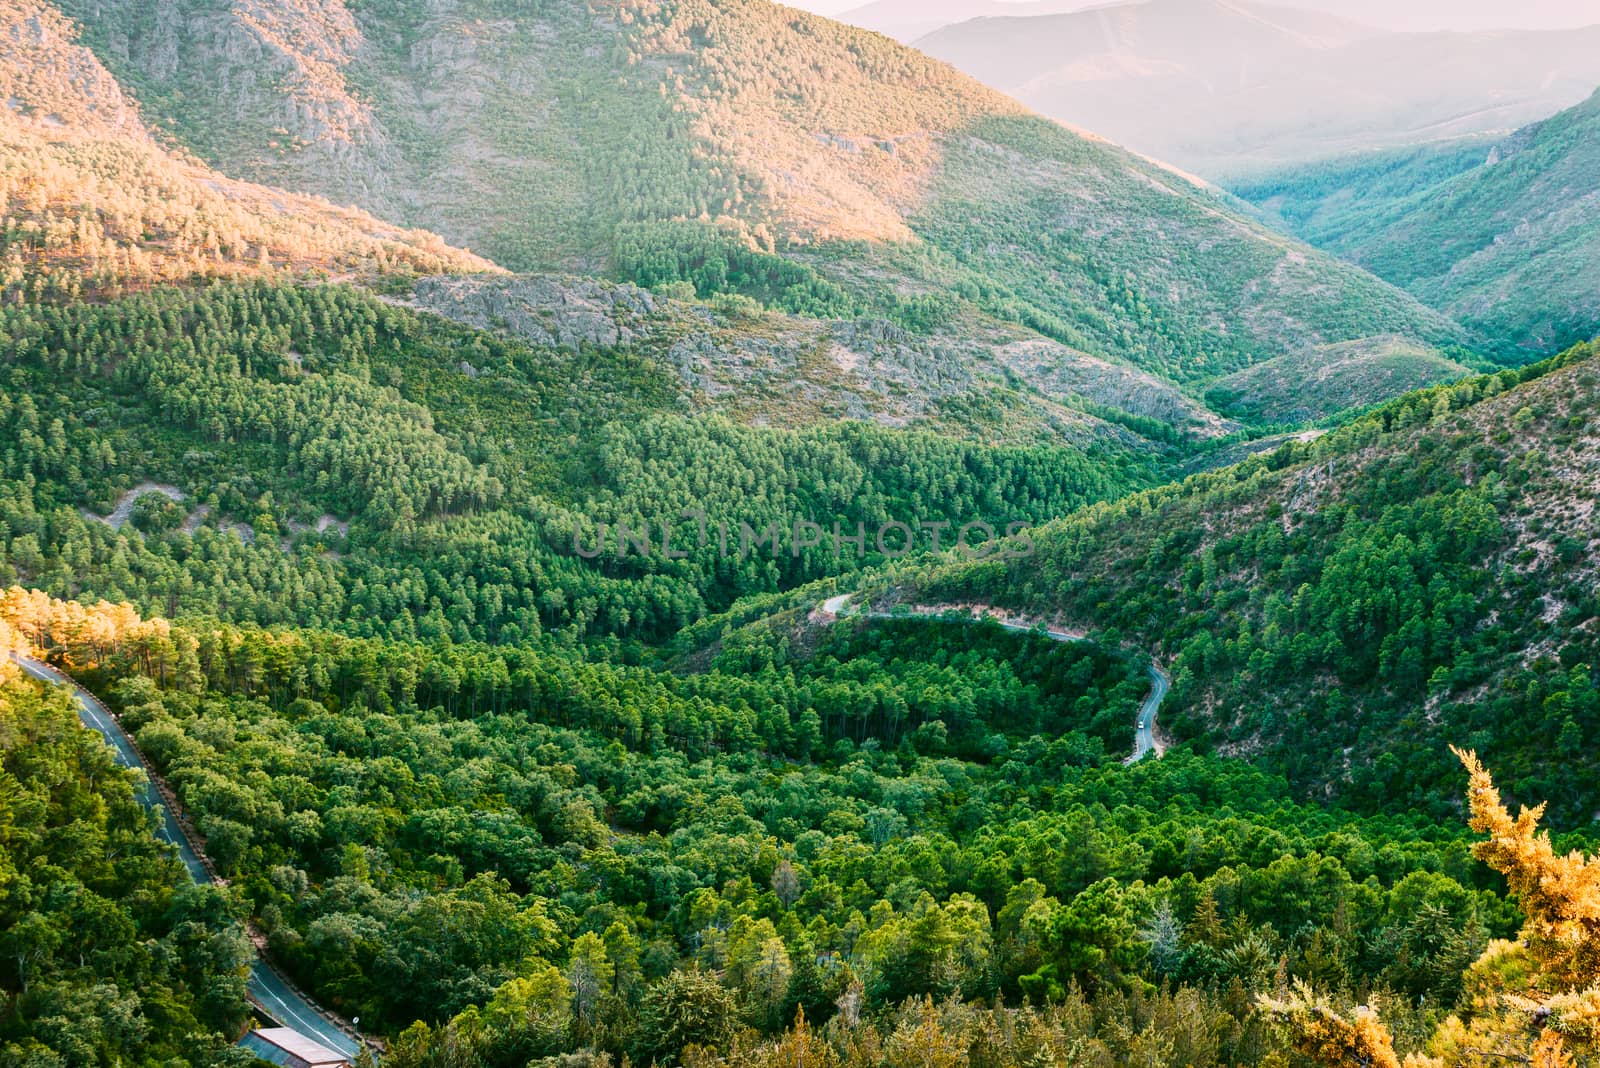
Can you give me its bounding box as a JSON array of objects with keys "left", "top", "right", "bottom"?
[{"left": 0, "top": 0, "right": 491, "bottom": 294}]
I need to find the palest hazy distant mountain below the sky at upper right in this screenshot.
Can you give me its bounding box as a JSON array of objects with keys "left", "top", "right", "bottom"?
[{"left": 917, "top": 0, "right": 1600, "bottom": 177}]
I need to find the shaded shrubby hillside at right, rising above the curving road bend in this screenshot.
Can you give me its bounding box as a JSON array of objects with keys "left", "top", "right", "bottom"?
[{"left": 920, "top": 347, "right": 1600, "bottom": 822}]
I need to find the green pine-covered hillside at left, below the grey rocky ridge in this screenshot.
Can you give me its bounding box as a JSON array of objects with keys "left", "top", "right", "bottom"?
[{"left": 0, "top": 283, "right": 1160, "bottom": 641}]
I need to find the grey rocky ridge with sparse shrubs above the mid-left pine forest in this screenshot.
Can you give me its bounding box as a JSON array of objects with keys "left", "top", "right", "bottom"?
[{"left": 408, "top": 275, "right": 1235, "bottom": 441}]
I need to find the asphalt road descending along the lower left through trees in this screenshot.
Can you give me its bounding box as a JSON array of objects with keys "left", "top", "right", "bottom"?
[{"left": 11, "top": 652, "right": 360, "bottom": 1060}]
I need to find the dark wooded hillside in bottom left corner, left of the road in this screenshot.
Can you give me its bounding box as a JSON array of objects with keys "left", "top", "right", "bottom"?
[{"left": 0, "top": 668, "right": 248, "bottom": 1065}]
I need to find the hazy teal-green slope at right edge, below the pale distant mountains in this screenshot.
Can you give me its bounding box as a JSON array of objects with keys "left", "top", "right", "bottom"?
[{"left": 1238, "top": 93, "right": 1600, "bottom": 355}]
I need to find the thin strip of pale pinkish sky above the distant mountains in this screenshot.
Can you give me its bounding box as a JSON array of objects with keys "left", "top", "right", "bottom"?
[{"left": 786, "top": 0, "right": 1600, "bottom": 30}]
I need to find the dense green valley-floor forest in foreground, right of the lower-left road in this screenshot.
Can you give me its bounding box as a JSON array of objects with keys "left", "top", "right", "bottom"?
[{"left": 0, "top": 592, "right": 1515, "bottom": 1065}]
